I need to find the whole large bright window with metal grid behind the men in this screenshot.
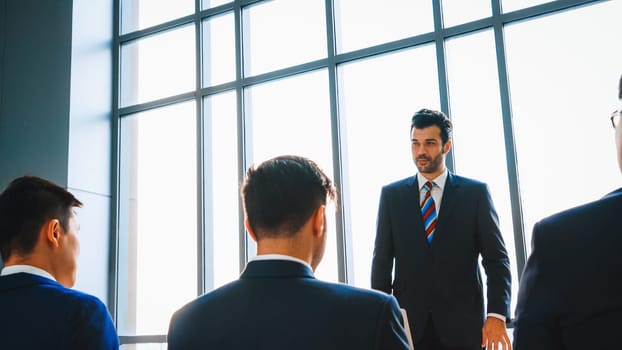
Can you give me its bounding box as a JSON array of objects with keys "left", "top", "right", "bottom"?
[{"left": 111, "top": 0, "right": 622, "bottom": 350}]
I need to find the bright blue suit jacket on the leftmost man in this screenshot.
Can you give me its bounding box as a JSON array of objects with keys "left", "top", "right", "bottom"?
[{"left": 0, "top": 273, "right": 119, "bottom": 350}]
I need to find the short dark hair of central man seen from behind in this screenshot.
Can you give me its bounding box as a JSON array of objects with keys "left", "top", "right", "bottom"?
[{"left": 242, "top": 155, "right": 335, "bottom": 238}]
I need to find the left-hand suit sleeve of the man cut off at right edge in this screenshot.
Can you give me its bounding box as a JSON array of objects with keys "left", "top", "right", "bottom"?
[{"left": 513, "top": 224, "right": 561, "bottom": 350}]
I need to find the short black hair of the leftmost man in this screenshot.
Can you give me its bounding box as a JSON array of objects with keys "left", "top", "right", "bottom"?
[{"left": 0, "top": 176, "right": 82, "bottom": 262}]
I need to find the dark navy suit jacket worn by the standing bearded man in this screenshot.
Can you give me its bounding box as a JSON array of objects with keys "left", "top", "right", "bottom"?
[{"left": 371, "top": 173, "right": 511, "bottom": 348}]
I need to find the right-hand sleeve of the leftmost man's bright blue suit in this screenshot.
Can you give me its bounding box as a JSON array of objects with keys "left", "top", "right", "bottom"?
[{"left": 69, "top": 296, "right": 119, "bottom": 350}]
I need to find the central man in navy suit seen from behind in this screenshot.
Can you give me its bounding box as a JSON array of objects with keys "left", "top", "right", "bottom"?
[{"left": 168, "top": 156, "right": 408, "bottom": 350}]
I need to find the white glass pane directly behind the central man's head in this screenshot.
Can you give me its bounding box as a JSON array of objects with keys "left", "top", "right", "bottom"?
[{"left": 246, "top": 70, "right": 338, "bottom": 281}]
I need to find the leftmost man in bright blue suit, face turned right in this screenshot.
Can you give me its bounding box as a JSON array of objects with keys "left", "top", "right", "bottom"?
[{"left": 0, "top": 176, "right": 119, "bottom": 350}]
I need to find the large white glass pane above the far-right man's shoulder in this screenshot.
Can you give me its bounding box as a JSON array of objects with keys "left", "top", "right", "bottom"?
[{"left": 505, "top": 1, "right": 622, "bottom": 251}]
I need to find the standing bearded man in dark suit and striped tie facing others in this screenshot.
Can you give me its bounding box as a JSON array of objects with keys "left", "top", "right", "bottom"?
[{"left": 371, "top": 109, "right": 511, "bottom": 350}]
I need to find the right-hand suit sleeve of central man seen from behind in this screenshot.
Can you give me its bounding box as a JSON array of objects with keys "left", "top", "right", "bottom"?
[{"left": 374, "top": 296, "right": 409, "bottom": 350}]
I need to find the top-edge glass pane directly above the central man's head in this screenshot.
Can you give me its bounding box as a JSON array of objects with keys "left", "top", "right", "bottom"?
[{"left": 244, "top": 0, "right": 326, "bottom": 76}]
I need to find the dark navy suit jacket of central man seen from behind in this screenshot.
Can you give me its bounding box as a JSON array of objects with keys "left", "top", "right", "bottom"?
[{"left": 168, "top": 260, "right": 408, "bottom": 350}]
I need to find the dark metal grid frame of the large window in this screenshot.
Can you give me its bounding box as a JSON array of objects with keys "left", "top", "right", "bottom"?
[{"left": 108, "top": 0, "right": 606, "bottom": 344}]
